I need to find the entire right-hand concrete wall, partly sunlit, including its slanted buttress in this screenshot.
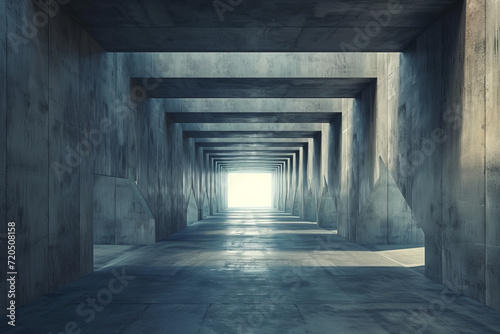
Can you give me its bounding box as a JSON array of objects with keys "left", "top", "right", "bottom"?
[{"left": 339, "top": 0, "right": 500, "bottom": 309}]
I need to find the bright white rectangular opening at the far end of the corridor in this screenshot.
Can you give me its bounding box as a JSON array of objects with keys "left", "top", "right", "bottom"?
[{"left": 227, "top": 173, "right": 272, "bottom": 208}]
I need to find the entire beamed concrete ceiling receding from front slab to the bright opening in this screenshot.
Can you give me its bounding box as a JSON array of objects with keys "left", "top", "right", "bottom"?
[{"left": 58, "top": 0, "right": 458, "bottom": 170}]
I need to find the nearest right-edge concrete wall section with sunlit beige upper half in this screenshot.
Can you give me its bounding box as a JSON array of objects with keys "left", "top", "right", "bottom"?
[{"left": 436, "top": 0, "right": 500, "bottom": 309}]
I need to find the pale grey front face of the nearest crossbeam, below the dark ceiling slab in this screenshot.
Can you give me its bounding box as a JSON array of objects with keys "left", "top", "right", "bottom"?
[{"left": 146, "top": 50, "right": 377, "bottom": 77}]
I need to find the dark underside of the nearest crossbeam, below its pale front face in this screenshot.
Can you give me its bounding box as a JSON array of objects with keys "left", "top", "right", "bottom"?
[{"left": 132, "top": 78, "right": 375, "bottom": 98}]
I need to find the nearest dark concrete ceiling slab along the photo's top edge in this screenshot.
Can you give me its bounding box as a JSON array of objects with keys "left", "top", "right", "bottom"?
[{"left": 64, "top": 0, "right": 456, "bottom": 52}]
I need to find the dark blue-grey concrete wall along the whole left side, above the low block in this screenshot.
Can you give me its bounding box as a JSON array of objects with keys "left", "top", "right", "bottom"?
[{"left": 0, "top": 0, "right": 186, "bottom": 309}]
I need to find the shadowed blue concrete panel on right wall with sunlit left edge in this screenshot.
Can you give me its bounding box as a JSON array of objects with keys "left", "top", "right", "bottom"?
[{"left": 379, "top": 18, "right": 444, "bottom": 281}]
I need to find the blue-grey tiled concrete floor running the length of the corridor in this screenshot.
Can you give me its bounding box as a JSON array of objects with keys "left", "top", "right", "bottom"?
[{"left": 0, "top": 211, "right": 500, "bottom": 334}]
